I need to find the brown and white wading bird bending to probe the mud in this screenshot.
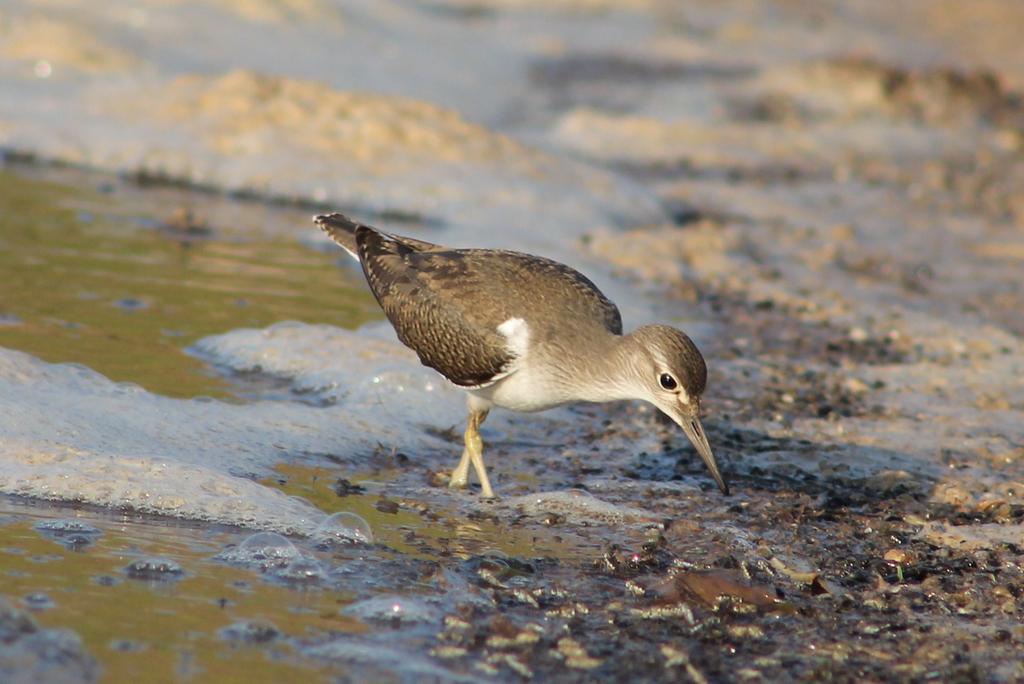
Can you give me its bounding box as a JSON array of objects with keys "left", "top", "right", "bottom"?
[{"left": 313, "top": 213, "right": 729, "bottom": 499}]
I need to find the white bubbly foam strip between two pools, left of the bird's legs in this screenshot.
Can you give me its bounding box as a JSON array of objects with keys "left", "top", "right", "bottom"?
[{"left": 0, "top": 327, "right": 461, "bottom": 533}]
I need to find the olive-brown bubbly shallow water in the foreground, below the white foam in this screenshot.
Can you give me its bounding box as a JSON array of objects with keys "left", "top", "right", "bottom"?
[{"left": 0, "top": 466, "right": 630, "bottom": 681}]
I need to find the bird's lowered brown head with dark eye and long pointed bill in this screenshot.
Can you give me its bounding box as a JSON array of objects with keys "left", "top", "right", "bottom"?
[{"left": 630, "top": 326, "right": 729, "bottom": 495}]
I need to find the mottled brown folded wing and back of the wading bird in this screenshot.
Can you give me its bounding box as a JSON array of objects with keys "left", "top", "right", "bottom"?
[{"left": 355, "top": 225, "right": 623, "bottom": 387}]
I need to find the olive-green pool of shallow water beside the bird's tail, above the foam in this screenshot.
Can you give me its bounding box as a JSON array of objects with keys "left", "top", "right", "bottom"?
[{"left": 0, "top": 167, "right": 380, "bottom": 397}]
